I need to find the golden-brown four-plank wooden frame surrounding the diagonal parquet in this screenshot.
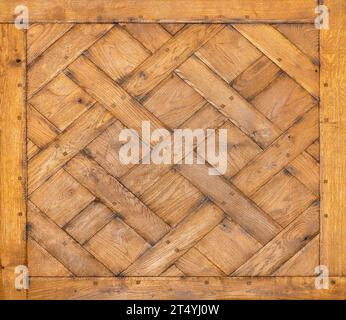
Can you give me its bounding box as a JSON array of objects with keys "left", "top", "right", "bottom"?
[{"left": 0, "top": 0, "right": 346, "bottom": 299}]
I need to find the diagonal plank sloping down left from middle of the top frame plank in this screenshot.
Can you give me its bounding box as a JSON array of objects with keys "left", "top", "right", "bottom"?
[{"left": 123, "top": 24, "right": 224, "bottom": 99}]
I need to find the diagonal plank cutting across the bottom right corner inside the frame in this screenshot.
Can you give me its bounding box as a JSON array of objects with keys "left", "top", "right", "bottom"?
[{"left": 232, "top": 201, "right": 319, "bottom": 276}]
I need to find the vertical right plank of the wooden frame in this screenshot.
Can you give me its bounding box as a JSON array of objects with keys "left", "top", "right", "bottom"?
[{"left": 321, "top": 0, "right": 346, "bottom": 275}]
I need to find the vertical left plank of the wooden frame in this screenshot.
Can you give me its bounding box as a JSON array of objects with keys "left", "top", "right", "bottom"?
[{"left": 0, "top": 24, "right": 26, "bottom": 299}]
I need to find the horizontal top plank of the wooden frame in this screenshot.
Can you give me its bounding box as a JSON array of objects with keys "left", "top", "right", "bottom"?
[{"left": 0, "top": 0, "right": 316, "bottom": 23}]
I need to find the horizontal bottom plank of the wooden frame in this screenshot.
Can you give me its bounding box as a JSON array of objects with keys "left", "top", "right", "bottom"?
[{"left": 29, "top": 277, "right": 346, "bottom": 300}]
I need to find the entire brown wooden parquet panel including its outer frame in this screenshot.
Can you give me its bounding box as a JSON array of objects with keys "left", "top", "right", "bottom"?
[{"left": 0, "top": 0, "right": 345, "bottom": 299}]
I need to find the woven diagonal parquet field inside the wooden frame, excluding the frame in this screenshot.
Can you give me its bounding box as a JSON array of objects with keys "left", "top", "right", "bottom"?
[{"left": 27, "top": 24, "right": 319, "bottom": 277}]
